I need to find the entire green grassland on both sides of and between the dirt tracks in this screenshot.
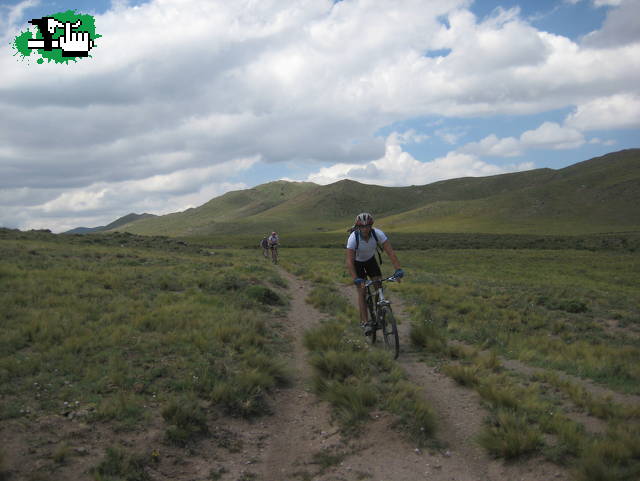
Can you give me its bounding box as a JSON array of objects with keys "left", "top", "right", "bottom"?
[{"left": 0, "top": 230, "right": 640, "bottom": 481}]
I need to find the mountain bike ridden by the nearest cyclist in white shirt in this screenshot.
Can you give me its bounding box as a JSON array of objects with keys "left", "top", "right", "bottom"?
[{"left": 364, "top": 276, "right": 400, "bottom": 359}]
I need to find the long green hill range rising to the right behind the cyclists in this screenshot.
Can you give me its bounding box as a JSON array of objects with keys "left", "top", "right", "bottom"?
[{"left": 104, "top": 149, "right": 640, "bottom": 236}]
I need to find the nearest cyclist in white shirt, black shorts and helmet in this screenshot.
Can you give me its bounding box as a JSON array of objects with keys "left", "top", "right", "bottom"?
[{"left": 346, "top": 212, "right": 404, "bottom": 335}]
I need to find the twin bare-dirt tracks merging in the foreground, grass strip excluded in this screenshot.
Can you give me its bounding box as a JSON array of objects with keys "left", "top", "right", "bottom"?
[{"left": 248, "top": 270, "right": 567, "bottom": 481}]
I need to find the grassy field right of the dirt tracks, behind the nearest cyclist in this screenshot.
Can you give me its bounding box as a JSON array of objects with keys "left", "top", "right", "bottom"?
[{"left": 282, "top": 249, "right": 640, "bottom": 481}]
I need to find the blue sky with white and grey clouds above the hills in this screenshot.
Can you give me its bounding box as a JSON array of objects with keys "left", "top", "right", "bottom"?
[{"left": 0, "top": 0, "right": 640, "bottom": 232}]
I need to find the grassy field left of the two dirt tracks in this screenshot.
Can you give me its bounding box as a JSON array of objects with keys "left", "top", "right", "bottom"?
[{"left": 0, "top": 231, "right": 289, "bottom": 479}]
